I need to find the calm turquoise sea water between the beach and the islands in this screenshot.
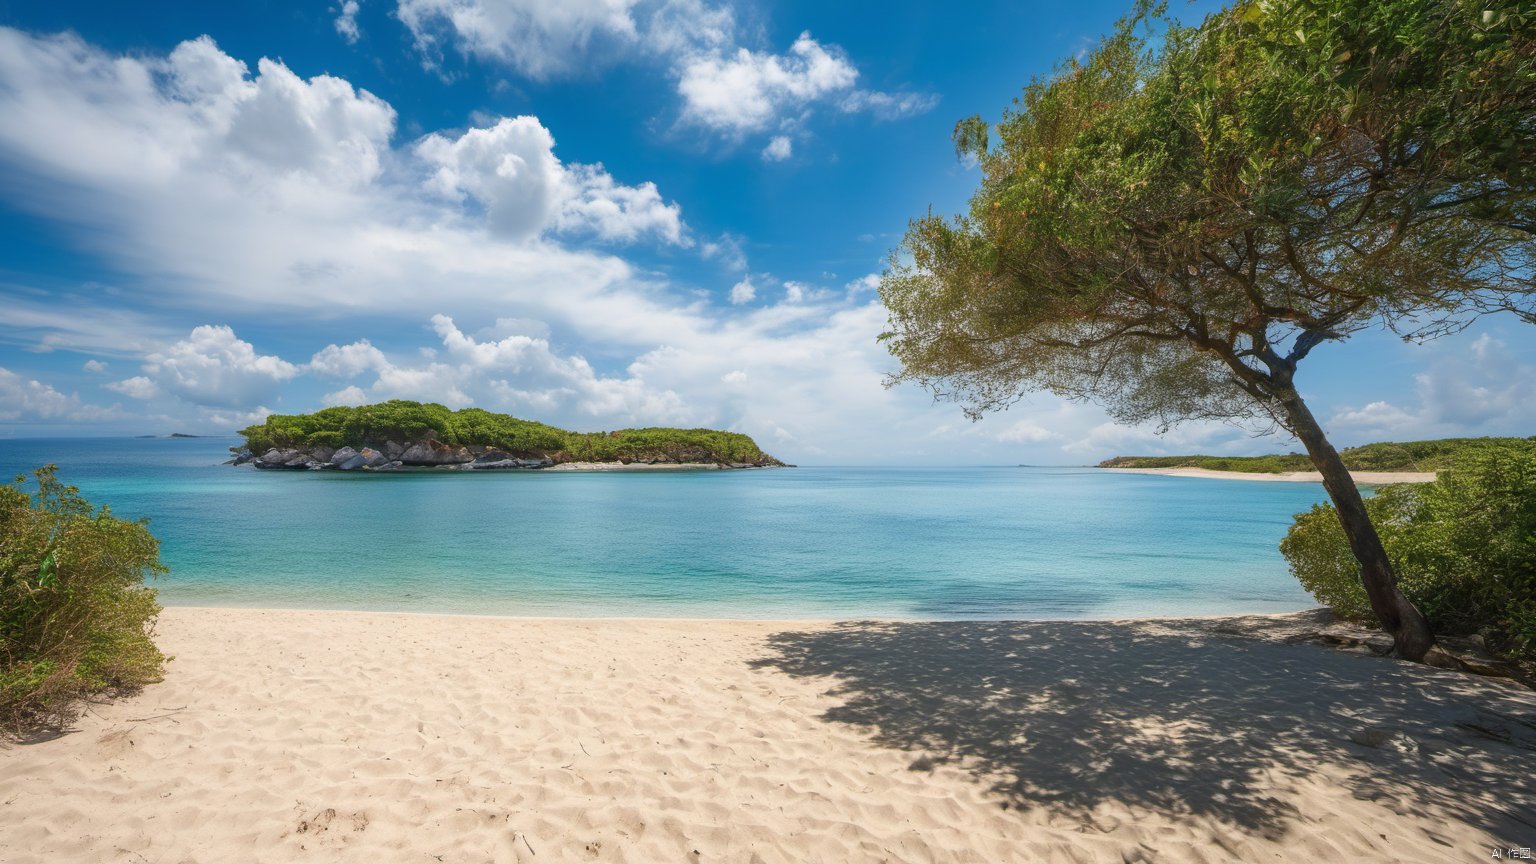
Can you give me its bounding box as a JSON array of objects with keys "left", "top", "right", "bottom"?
[{"left": 0, "top": 438, "right": 1322, "bottom": 618}]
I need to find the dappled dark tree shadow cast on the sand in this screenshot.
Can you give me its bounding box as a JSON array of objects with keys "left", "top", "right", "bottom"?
[{"left": 754, "top": 618, "right": 1536, "bottom": 846}]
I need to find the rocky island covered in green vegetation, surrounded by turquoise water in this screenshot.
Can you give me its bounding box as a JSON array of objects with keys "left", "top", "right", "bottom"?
[{"left": 229, "top": 400, "right": 793, "bottom": 470}]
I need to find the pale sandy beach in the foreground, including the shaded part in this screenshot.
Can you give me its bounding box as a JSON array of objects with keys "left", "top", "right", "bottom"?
[{"left": 0, "top": 609, "right": 1536, "bottom": 864}]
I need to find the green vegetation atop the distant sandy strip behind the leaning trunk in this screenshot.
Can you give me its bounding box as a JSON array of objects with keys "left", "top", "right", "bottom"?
[{"left": 1098, "top": 438, "right": 1536, "bottom": 474}]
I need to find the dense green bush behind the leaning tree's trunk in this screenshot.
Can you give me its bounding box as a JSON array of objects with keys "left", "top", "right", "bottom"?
[{"left": 1279, "top": 440, "right": 1536, "bottom": 660}]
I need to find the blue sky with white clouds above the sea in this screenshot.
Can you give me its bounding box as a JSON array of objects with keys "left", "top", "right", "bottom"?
[{"left": 0, "top": 0, "right": 1536, "bottom": 464}]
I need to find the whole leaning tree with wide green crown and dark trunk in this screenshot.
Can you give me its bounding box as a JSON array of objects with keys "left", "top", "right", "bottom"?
[{"left": 880, "top": 0, "right": 1536, "bottom": 661}]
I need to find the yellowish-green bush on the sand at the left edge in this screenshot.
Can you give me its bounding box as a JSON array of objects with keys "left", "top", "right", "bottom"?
[{"left": 0, "top": 466, "right": 164, "bottom": 733}]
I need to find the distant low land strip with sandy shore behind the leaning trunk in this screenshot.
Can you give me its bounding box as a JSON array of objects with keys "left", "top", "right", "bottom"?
[{"left": 1098, "top": 438, "right": 1536, "bottom": 484}]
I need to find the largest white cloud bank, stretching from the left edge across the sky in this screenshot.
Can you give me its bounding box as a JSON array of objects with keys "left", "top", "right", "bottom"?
[{"left": 0, "top": 28, "right": 694, "bottom": 355}]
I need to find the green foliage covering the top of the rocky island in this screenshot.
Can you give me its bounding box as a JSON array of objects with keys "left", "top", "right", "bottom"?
[{"left": 240, "top": 400, "right": 771, "bottom": 463}]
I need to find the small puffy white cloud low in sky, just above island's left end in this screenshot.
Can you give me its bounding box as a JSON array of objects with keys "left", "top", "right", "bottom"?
[{"left": 142, "top": 324, "right": 301, "bottom": 409}]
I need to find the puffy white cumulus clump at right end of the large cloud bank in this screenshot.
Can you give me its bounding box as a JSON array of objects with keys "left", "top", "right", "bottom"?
[{"left": 416, "top": 117, "right": 687, "bottom": 244}]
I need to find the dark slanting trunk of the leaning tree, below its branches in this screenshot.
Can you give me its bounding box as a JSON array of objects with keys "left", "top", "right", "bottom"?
[{"left": 1276, "top": 387, "right": 1442, "bottom": 663}]
